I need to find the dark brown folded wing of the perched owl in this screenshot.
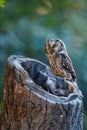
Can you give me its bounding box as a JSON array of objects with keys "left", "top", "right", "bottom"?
[{"left": 60, "top": 53, "right": 76, "bottom": 80}]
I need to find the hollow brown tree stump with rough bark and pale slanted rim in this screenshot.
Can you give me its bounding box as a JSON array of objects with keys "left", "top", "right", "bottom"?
[{"left": 0, "top": 55, "right": 83, "bottom": 130}]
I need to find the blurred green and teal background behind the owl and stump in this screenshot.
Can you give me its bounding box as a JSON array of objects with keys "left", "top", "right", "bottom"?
[{"left": 0, "top": 0, "right": 87, "bottom": 130}]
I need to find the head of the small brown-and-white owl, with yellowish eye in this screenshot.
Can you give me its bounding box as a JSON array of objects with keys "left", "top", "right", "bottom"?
[{"left": 45, "top": 39, "right": 66, "bottom": 55}]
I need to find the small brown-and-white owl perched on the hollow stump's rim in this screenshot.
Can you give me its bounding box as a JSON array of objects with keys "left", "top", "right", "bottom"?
[{"left": 45, "top": 39, "right": 76, "bottom": 91}]
